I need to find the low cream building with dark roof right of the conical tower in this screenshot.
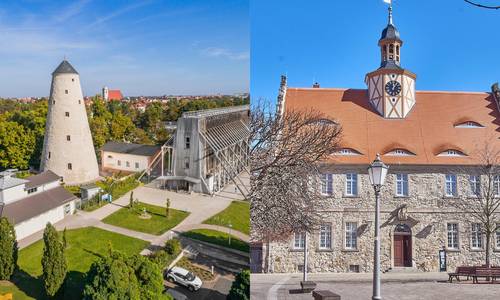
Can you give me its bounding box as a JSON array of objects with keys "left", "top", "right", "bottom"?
[{"left": 101, "top": 142, "right": 161, "bottom": 173}]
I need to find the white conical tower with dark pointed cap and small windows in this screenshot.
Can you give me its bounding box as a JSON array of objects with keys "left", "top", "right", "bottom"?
[{"left": 40, "top": 60, "right": 99, "bottom": 185}]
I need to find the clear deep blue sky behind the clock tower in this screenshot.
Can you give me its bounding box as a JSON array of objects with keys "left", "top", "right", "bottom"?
[{"left": 250, "top": 0, "right": 500, "bottom": 101}]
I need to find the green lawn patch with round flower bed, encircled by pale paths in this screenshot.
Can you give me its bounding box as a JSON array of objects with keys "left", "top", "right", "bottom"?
[{"left": 102, "top": 202, "right": 189, "bottom": 235}]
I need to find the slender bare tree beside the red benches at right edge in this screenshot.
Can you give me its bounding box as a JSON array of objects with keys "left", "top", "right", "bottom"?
[{"left": 452, "top": 142, "right": 500, "bottom": 267}]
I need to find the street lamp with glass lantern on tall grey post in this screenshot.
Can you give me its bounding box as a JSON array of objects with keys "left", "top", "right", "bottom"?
[{"left": 368, "top": 153, "right": 389, "bottom": 300}]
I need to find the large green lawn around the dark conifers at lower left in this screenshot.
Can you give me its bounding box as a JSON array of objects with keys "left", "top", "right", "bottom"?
[{"left": 0, "top": 227, "right": 148, "bottom": 300}]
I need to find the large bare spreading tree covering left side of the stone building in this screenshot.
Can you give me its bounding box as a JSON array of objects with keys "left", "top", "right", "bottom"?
[{"left": 249, "top": 102, "right": 341, "bottom": 281}]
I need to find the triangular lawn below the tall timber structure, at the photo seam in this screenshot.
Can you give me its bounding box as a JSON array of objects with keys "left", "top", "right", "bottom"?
[{"left": 203, "top": 201, "right": 250, "bottom": 235}]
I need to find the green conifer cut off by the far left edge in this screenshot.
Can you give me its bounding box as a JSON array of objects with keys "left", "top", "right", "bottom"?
[{"left": 0, "top": 217, "right": 17, "bottom": 280}]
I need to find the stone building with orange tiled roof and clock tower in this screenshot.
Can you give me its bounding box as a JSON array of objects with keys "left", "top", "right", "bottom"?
[{"left": 252, "top": 7, "right": 500, "bottom": 272}]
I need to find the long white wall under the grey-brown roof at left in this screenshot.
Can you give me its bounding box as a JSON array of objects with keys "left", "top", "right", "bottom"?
[{"left": 14, "top": 201, "right": 75, "bottom": 240}]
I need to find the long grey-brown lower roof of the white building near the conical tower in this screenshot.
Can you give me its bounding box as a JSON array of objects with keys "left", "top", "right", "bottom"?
[{"left": 1, "top": 186, "right": 76, "bottom": 224}]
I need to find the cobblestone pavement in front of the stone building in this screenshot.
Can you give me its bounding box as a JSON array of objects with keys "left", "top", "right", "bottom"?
[{"left": 251, "top": 273, "right": 500, "bottom": 300}]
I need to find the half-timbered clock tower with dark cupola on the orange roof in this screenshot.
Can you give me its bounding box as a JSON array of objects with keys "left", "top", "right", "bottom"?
[{"left": 365, "top": 4, "right": 417, "bottom": 119}]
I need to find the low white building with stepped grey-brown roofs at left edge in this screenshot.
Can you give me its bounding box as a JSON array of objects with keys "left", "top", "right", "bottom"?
[{"left": 0, "top": 170, "right": 78, "bottom": 239}]
